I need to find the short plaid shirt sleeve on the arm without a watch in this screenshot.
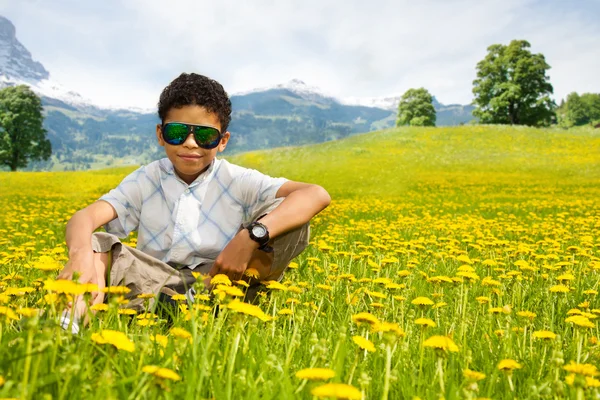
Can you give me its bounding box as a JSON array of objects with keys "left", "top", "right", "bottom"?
[{"left": 100, "top": 167, "right": 145, "bottom": 238}]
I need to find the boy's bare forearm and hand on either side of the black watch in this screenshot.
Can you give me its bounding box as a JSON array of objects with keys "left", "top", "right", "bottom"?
[{"left": 210, "top": 181, "right": 331, "bottom": 280}]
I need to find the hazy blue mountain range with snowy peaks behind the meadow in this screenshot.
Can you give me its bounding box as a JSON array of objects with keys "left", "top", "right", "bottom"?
[{"left": 0, "top": 16, "right": 472, "bottom": 170}]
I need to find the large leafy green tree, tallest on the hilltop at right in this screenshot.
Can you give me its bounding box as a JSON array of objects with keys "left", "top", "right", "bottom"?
[{"left": 473, "top": 40, "right": 556, "bottom": 126}]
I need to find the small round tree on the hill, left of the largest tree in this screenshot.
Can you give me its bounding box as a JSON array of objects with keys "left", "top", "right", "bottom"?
[{"left": 396, "top": 88, "right": 435, "bottom": 126}]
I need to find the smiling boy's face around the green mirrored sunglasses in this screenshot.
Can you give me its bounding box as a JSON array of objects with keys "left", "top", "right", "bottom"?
[{"left": 156, "top": 105, "right": 230, "bottom": 185}]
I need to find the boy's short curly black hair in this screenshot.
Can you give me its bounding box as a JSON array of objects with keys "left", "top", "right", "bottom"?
[{"left": 158, "top": 72, "right": 231, "bottom": 132}]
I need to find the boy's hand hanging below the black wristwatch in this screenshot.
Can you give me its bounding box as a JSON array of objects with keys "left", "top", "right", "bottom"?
[{"left": 209, "top": 229, "right": 258, "bottom": 281}]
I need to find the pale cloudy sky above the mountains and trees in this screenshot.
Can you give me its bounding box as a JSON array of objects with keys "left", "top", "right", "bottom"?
[{"left": 0, "top": 0, "right": 600, "bottom": 108}]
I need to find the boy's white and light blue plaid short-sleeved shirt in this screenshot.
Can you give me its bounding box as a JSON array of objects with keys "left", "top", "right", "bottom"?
[{"left": 100, "top": 158, "right": 287, "bottom": 268}]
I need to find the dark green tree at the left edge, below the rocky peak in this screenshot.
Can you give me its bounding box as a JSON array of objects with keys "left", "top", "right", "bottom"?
[{"left": 0, "top": 85, "right": 52, "bottom": 171}]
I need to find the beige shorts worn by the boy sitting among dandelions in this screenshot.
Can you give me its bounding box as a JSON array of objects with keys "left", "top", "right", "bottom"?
[{"left": 92, "top": 199, "right": 310, "bottom": 311}]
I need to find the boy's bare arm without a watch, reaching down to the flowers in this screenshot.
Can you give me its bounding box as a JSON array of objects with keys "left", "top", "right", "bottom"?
[{"left": 58, "top": 200, "right": 117, "bottom": 284}]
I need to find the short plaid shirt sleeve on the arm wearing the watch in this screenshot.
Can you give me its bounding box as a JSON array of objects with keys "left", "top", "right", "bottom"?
[{"left": 239, "top": 169, "right": 288, "bottom": 220}]
